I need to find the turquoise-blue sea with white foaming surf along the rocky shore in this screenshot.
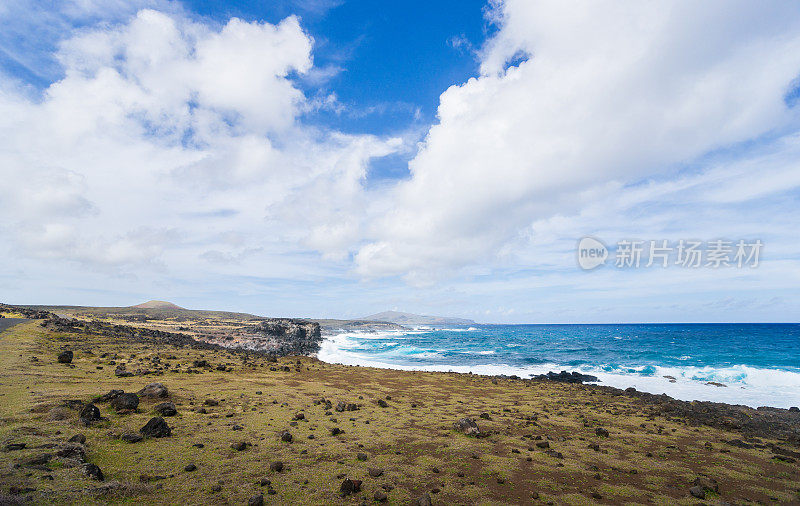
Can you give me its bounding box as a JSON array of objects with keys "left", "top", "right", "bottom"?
[{"left": 319, "top": 323, "right": 800, "bottom": 408}]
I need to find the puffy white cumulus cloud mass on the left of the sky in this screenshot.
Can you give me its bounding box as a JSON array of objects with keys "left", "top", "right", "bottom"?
[{"left": 0, "top": 8, "right": 398, "bottom": 274}]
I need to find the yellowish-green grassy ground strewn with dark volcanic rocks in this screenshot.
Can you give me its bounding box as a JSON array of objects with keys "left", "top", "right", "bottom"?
[{"left": 0, "top": 322, "right": 800, "bottom": 505}]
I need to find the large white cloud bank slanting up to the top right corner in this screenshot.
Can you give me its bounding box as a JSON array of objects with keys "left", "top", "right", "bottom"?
[{"left": 355, "top": 0, "right": 800, "bottom": 279}]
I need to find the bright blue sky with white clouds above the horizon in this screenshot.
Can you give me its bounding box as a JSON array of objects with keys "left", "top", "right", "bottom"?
[{"left": 0, "top": 0, "right": 800, "bottom": 323}]
